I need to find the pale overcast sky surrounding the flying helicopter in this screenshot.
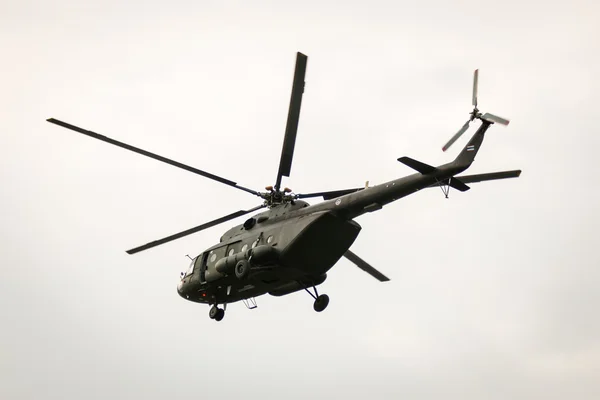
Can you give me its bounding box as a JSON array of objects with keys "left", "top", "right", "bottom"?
[{"left": 0, "top": 0, "right": 600, "bottom": 399}]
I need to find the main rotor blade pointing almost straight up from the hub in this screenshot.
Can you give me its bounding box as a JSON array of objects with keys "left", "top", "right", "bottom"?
[{"left": 275, "top": 53, "right": 308, "bottom": 190}]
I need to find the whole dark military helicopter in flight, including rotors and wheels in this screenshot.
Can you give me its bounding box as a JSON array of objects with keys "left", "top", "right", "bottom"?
[{"left": 47, "top": 53, "right": 521, "bottom": 321}]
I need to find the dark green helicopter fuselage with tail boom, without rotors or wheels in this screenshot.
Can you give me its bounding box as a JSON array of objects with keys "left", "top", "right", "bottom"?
[{"left": 173, "top": 124, "right": 482, "bottom": 304}]
